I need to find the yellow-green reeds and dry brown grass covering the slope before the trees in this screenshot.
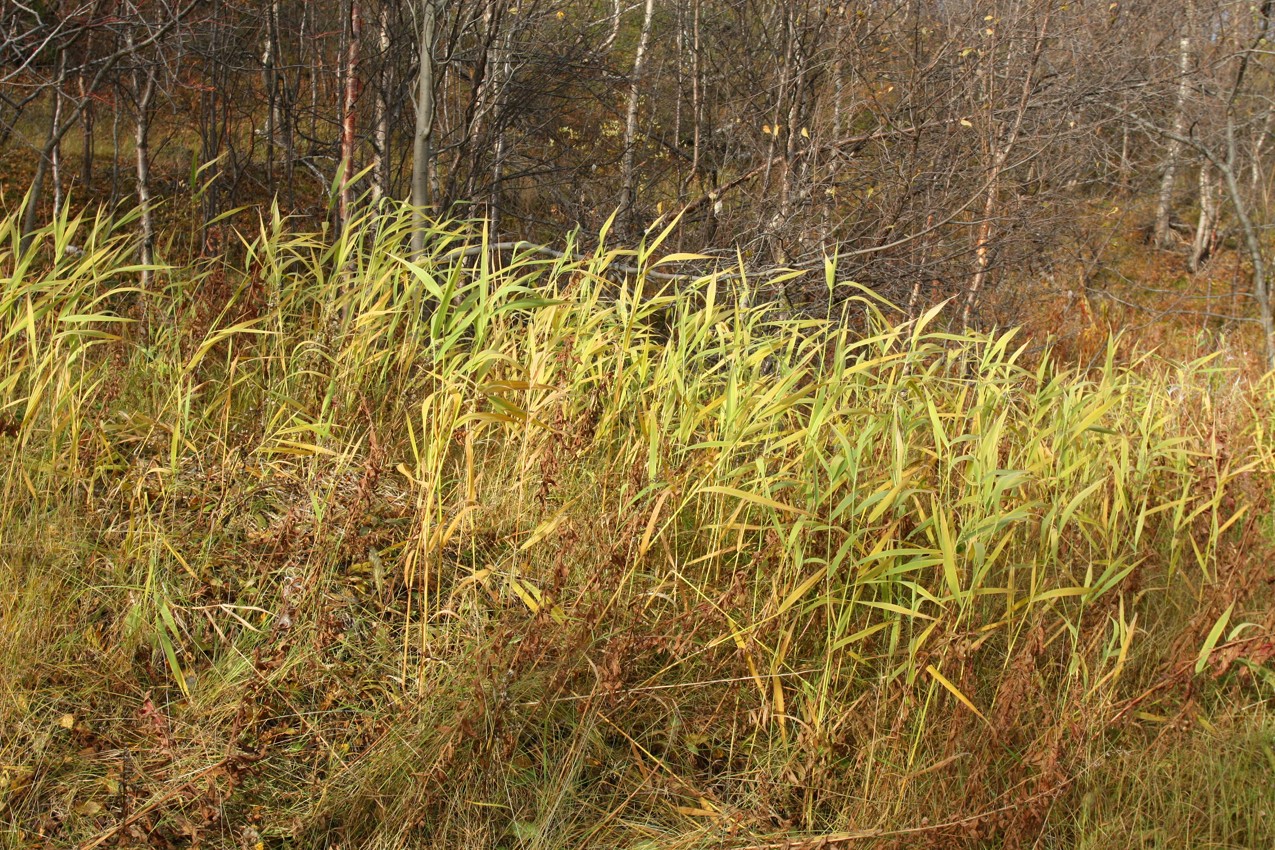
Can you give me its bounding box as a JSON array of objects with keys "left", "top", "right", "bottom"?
[{"left": 0, "top": 207, "right": 1275, "bottom": 850}]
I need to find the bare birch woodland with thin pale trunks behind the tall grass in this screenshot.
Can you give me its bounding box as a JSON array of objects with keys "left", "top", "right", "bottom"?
[{"left": 7, "top": 0, "right": 1275, "bottom": 357}]
